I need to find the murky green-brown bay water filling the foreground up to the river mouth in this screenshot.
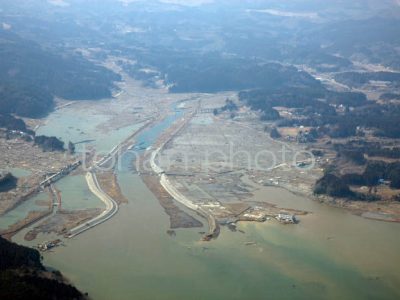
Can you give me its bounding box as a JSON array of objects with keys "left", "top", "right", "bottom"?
[{"left": 32, "top": 173, "right": 399, "bottom": 299}]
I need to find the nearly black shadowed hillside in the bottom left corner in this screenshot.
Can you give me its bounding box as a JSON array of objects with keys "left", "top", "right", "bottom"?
[{"left": 0, "top": 237, "right": 86, "bottom": 300}]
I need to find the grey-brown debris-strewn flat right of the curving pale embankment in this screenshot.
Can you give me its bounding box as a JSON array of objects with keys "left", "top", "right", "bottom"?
[{"left": 151, "top": 101, "right": 315, "bottom": 228}]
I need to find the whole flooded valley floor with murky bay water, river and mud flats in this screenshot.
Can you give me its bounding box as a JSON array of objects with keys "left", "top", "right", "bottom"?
[{"left": 1, "top": 69, "right": 400, "bottom": 299}]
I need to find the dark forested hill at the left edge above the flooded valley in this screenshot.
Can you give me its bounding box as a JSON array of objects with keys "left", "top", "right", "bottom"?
[{"left": 0, "top": 29, "right": 120, "bottom": 117}]
